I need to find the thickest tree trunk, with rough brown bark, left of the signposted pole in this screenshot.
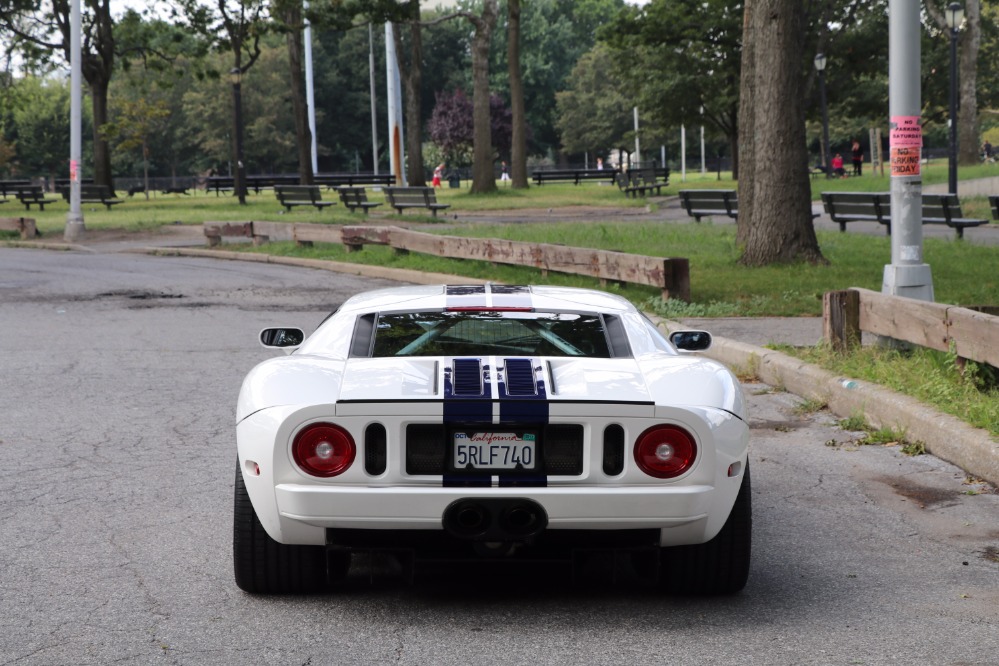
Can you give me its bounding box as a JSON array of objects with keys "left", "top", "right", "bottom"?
[{"left": 738, "top": 0, "right": 824, "bottom": 266}]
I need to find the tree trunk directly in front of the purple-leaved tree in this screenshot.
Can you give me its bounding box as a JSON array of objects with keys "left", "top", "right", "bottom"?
[{"left": 471, "top": 0, "right": 498, "bottom": 193}]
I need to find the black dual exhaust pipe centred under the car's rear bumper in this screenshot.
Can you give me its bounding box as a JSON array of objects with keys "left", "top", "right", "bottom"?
[{"left": 443, "top": 498, "right": 548, "bottom": 541}]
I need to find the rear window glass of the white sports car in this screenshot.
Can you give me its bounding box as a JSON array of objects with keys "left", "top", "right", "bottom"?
[{"left": 368, "top": 311, "right": 611, "bottom": 358}]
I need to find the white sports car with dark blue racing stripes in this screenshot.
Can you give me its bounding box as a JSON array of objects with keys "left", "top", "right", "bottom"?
[{"left": 233, "top": 285, "right": 752, "bottom": 594}]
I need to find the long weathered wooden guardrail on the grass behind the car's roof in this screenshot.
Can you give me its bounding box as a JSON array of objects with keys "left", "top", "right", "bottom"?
[{"left": 204, "top": 222, "right": 690, "bottom": 302}]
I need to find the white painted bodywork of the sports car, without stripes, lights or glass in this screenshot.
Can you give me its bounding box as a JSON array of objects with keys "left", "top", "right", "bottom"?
[{"left": 236, "top": 286, "right": 749, "bottom": 546}]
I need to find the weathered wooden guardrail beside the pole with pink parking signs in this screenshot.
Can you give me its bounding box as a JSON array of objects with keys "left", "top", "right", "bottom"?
[{"left": 823, "top": 288, "right": 999, "bottom": 367}]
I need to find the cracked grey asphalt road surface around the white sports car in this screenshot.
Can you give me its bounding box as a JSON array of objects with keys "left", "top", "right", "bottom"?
[{"left": 0, "top": 248, "right": 999, "bottom": 665}]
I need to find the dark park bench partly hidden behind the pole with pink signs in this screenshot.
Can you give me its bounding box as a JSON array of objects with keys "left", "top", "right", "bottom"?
[{"left": 822, "top": 192, "right": 989, "bottom": 238}]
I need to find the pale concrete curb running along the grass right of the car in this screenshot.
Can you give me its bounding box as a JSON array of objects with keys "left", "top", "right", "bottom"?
[{"left": 660, "top": 320, "right": 999, "bottom": 486}]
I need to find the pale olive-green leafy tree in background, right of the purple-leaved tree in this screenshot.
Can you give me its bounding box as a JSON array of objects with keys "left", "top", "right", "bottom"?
[{"left": 555, "top": 44, "right": 633, "bottom": 155}]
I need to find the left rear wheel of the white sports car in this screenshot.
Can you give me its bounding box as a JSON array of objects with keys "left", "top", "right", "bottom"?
[{"left": 232, "top": 462, "right": 350, "bottom": 594}]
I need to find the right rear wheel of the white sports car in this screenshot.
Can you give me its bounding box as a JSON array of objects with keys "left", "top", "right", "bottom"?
[{"left": 659, "top": 461, "right": 753, "bottom": 595}]
